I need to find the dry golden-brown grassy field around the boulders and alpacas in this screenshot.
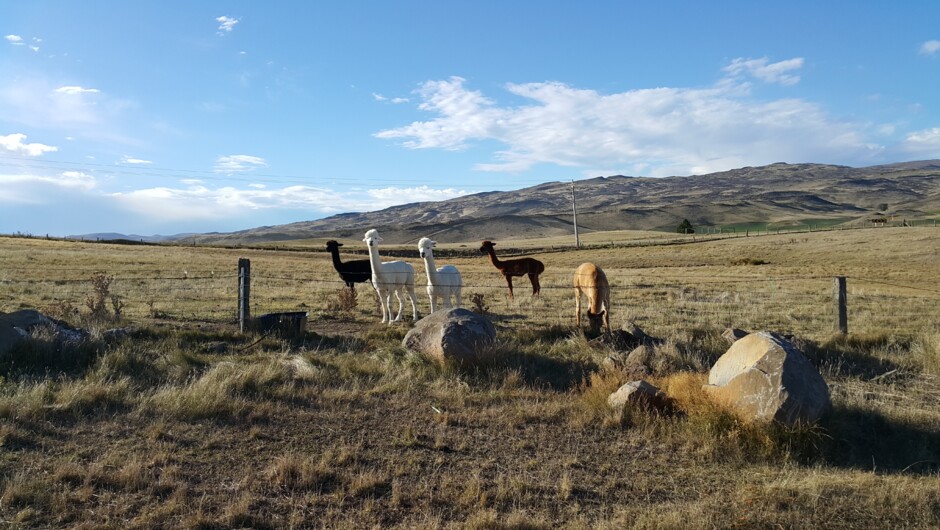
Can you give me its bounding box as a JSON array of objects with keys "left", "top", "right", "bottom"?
[{"left": 0, "top": 227, "right": 940, "bottom": 528}]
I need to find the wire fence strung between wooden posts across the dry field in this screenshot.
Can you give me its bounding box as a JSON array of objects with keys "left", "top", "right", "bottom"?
[{"left": 0, "top": 266, "right": 940, "bottom": 336}]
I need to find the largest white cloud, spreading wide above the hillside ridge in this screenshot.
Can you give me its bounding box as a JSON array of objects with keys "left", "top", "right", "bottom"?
[{"left": 375, "top": 73, "right": 882, "bottom": 176}]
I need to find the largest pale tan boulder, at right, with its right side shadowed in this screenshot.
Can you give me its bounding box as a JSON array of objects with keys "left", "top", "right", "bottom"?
[{"left": 705, "top": 331, "right": 831, "bottom": 424}]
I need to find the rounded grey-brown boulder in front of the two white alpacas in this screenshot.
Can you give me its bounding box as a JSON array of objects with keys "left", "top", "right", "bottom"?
[{"left": 402, "top": 308, "right": 496, "bottom": 364}]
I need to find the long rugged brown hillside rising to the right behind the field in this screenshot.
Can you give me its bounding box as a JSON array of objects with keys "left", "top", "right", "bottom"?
[{"left": 183, "top": 160, "right": 940, "bottom": 243}]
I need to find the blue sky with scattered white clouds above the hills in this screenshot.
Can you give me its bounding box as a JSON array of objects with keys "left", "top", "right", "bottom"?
[{"left": 0, "top": 0, "right": 940, "bottom": 236}]
